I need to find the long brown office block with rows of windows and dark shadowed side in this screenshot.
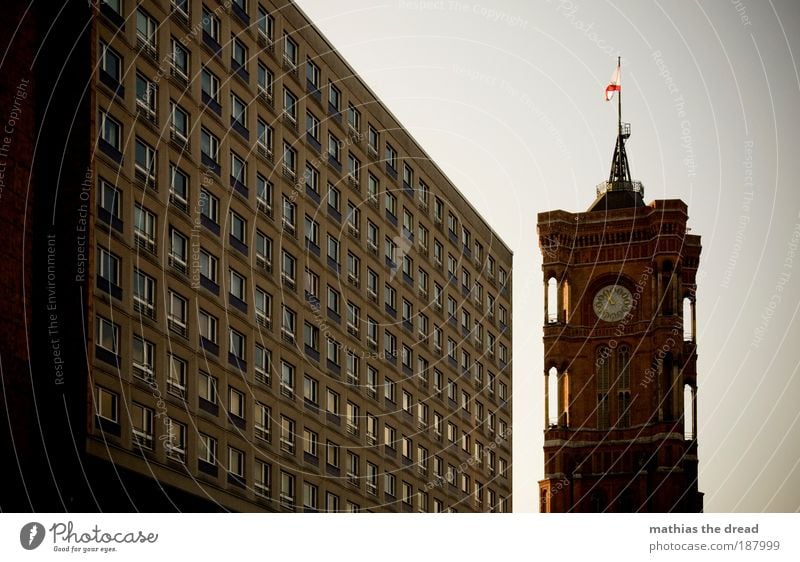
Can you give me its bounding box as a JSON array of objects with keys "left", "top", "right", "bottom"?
[{"left": 3, "top": 0, "right": 512, "bottom": 512}]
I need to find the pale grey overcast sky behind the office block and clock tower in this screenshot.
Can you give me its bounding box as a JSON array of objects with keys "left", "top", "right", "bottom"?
[{"left": 297, "top": 0, "right": 800, "bottom": 511}]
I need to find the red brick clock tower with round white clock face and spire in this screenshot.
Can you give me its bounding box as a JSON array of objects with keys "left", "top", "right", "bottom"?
[{"left": 538, "top": 94, "right": 703, "bottom": 513}]
